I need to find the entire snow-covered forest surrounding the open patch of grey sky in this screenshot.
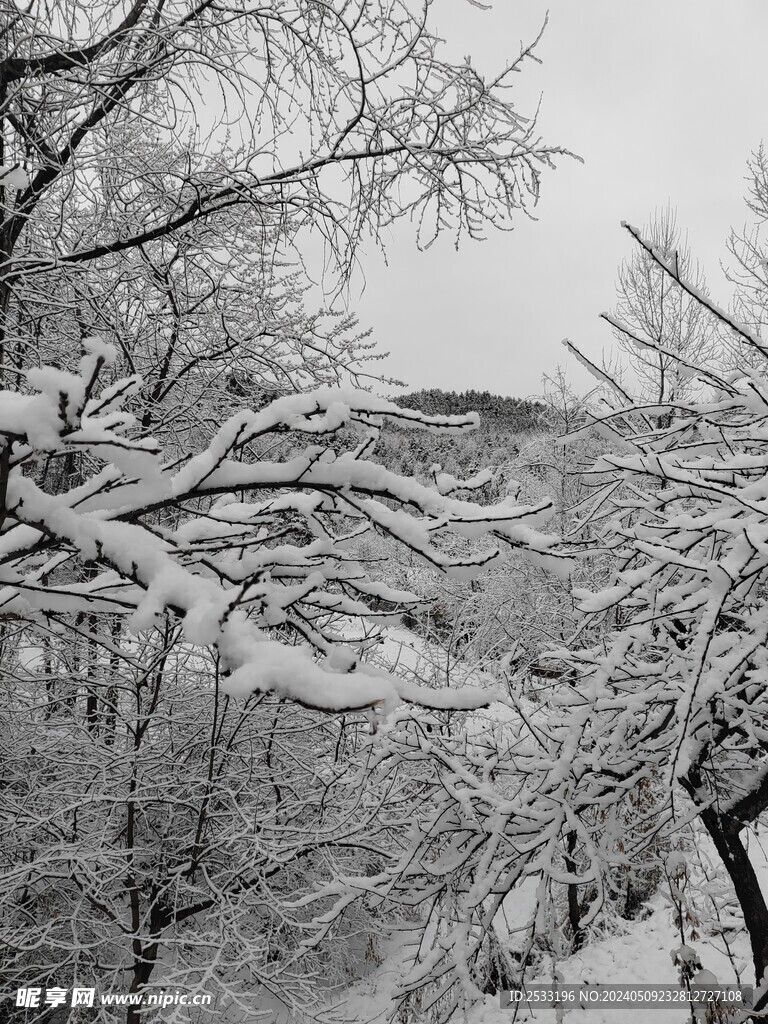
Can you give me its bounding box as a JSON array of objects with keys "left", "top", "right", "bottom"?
[{"left": 0, "top": 0, "right": 768, "bottom": 1024}]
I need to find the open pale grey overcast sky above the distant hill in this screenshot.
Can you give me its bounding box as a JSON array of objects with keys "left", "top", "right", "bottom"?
[{"left": 350, "top": 0, "right": 768, "bottom": 395}]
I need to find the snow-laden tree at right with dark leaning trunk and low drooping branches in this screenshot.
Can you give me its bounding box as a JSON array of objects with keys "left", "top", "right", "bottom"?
[{"left": 325, "top": 214, "right": 768, "bottom": 1021}]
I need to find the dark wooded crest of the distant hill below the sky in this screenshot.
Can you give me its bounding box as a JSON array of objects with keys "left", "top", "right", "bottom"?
[{"left": 392, "top": 388, "right": 545, "bottom": 434}]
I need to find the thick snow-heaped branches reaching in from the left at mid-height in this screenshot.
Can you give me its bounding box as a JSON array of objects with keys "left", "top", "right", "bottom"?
[{"left": 0, "top": 339, "right": 571, "bottom": 711}]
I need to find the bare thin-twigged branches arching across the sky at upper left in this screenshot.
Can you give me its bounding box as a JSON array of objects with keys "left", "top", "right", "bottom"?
[{"left": 0, "top": 0, "right": 561, "bottom": 356}]
